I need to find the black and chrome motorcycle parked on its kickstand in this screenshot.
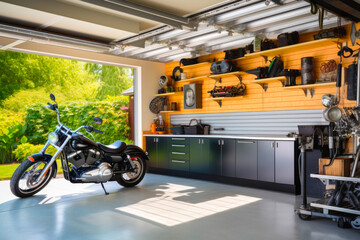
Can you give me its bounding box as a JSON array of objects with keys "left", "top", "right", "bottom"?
[{"left": 10, "top": 94, "right": 149, "bottom": 198}]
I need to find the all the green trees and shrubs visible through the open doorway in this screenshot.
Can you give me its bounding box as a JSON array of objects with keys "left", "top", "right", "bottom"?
[{"left": 0, "top": 51, "right": 133, "bottom": 169}]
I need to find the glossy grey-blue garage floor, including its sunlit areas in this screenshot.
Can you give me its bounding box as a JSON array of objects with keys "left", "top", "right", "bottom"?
[{"left": 0, "top": 174, "right": 360, "bottom": 240}]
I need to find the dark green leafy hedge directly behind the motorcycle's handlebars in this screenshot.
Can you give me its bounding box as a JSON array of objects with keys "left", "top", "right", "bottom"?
[{"left": 25, "top": 99, "right": 130, "bottom": 144}]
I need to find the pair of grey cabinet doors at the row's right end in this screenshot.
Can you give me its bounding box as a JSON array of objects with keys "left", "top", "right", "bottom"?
[{"left": 258, "top": 141, "right": 295, "bottom": 185}]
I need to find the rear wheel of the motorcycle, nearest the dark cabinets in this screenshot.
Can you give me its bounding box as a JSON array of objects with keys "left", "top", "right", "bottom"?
[{"left": 117, "top": 157, "right": 146, "bottom": 187}]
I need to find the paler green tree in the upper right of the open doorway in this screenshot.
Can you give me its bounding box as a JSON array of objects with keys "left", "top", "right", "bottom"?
[{"left": 85, "top": 63, "right": 133, "bottom": 100}]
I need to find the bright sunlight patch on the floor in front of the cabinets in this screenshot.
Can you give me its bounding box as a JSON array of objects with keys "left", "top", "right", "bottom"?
[{"left": 116, "top": 184, "right": 261, "bottom": 227}]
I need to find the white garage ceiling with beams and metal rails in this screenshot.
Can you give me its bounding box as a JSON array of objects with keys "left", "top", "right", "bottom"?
[{"left": 0, "top": 0, "right": 352, "bottom": 62}]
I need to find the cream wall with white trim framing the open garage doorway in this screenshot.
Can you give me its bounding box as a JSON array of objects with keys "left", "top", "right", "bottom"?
[{"left": 0, "top": 38, "right": 165, "bottom": 146}]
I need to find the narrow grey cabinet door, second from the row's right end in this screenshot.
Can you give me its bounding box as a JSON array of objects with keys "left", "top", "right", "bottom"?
[{"left": 258, "top": 141, "right": 275, "bottom": 182}]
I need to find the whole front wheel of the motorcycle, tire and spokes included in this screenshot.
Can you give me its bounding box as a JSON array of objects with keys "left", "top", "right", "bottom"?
[{"left": 10, "top": 159, "right": 56, "bottom": 198}]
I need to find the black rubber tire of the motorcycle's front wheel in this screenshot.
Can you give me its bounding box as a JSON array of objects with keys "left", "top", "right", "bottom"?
[{"left": 10, "top": 159, "right": 56, "bottom": 198}]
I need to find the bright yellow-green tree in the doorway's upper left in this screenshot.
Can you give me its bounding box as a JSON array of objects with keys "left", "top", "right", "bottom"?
[{"left": 0, "top": 51, "right": 97, "bottom": 103}]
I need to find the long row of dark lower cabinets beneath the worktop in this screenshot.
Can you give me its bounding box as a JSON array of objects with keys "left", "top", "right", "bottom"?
[{"left": 146, "top": 136, "right": 297, "bottom": 192}]
